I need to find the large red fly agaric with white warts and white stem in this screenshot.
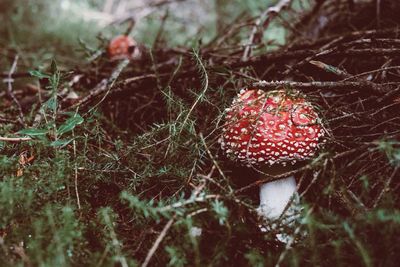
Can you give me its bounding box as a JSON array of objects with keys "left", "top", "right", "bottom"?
[{"left": 219, "top": 89, "right": 324, "bottom": 220}]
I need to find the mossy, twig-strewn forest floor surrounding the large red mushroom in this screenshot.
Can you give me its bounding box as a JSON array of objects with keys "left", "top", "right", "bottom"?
[{"left": 0, "top": 0, "right": 400, "bottom": 267}]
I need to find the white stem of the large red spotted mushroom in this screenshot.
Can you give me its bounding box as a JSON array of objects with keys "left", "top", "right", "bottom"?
[{"left": 258, "top": 176, "right": 296, "bottom": 220}]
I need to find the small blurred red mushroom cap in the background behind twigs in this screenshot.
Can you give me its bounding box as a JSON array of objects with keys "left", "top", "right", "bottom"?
[{"left": 108, "top": 35, "right": 141, "bottom": 60}]
